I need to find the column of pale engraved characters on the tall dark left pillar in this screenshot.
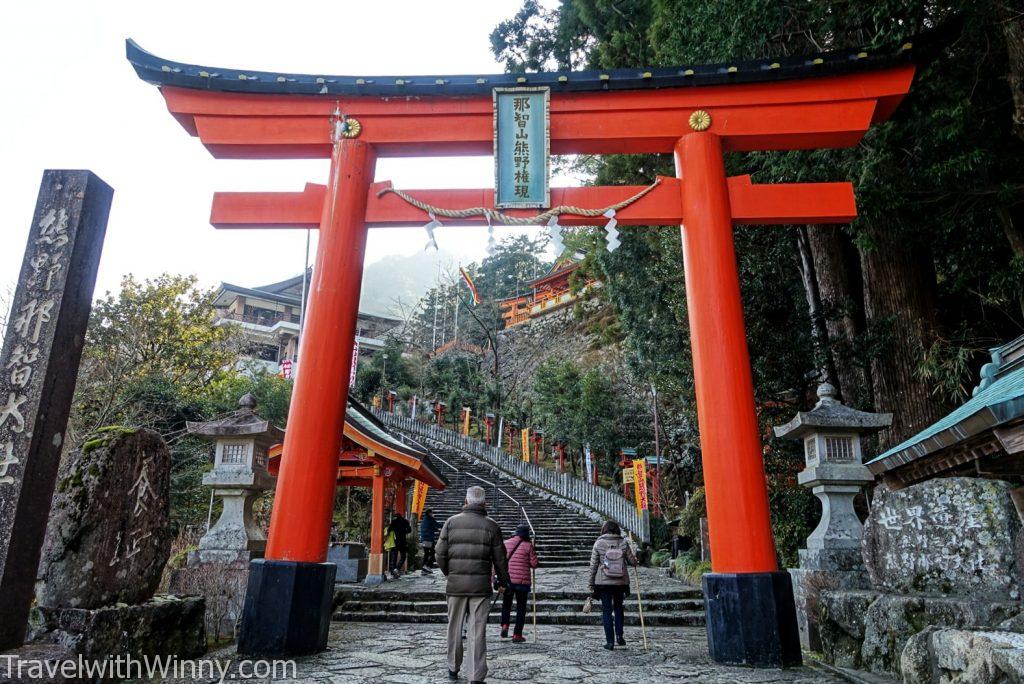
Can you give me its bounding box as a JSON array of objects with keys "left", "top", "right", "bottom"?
[{"left": 0, "top": 208, "right": 71, "bottom": 487}]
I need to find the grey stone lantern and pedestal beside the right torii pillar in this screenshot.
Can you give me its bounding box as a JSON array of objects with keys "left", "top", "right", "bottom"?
[{"left": 774, "top": 383, "right": 892, "bottom": 650}]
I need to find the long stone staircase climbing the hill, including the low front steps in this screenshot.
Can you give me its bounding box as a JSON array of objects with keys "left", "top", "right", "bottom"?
[{"left": 334, "top": 426, "right": 705, "bottom": 626}]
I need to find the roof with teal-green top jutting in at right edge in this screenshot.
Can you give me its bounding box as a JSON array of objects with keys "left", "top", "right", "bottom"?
[{"left": 866, "top": 336, "right": 1024, "bottom": 474}]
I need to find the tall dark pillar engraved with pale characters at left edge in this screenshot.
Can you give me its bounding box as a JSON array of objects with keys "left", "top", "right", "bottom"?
[{"left": 0, "top": 170, "right": 114, "bottom": 650}]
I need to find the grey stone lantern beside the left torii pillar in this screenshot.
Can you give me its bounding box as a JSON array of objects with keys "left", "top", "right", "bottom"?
[{"left": 187, "top": 394, "right": 285, "bottom": 563}]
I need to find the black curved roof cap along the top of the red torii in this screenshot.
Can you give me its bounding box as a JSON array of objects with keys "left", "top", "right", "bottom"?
[{"left": 126, "top": 38, "right": 920, "bottom": 96}]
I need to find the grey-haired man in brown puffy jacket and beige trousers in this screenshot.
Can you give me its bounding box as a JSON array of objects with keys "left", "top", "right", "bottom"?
[{"left": 436, "top": 486, "right": 509, "bottom": 682}]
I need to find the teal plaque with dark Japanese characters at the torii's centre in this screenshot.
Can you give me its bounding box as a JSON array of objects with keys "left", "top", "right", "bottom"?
[{"left": 494, "top": 88, "right": 551, "bottom": 209}]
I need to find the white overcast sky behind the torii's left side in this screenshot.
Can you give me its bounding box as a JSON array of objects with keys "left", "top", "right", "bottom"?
[{"left": 0, "top": 0, "right": 561, "bottom": 295}]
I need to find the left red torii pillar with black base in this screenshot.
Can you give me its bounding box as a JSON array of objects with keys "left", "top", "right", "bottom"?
[{"left": 238, "top": 135, "right": 383, "bottom": 655}]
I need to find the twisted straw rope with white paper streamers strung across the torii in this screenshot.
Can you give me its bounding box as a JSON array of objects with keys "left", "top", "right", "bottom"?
[{"left": 377, "top": 178, "right": 662, "bottom": 254}]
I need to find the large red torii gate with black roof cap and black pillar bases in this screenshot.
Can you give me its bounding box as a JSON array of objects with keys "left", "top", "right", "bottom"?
[{"left": 128, "top": 41, "right": 914, "bottom": 666}]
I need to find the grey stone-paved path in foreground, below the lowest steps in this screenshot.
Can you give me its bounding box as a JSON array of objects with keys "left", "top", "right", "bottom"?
[{"left": 205, "top": 623, "right": 831, "bottom": 684}]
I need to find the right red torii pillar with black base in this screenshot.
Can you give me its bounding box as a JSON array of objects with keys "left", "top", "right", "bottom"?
[{"left": 675, "top": 131, "right": 801, "bottom": 667}]
